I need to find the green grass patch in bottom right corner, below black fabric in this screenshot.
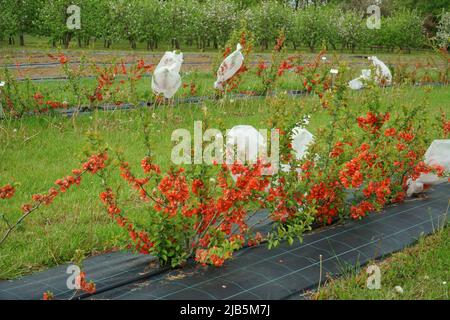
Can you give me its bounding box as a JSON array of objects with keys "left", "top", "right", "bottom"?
[{"left": 311, "top": 227, "right": 450, "bottom": 300}]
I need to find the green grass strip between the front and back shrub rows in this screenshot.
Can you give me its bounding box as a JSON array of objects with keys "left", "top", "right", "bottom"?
[{"left": 0, "top": 83, "right": 450, "bottom": 279}]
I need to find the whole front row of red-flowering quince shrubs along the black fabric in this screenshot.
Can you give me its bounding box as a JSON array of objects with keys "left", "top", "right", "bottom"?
[{"left": 86, "top": 57, "right": 449, "bottom": 267}]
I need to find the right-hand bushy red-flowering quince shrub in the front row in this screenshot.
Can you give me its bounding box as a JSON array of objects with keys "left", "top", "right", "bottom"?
[{"left": 282, "top": 85, "right": 445, "bottom": 228}]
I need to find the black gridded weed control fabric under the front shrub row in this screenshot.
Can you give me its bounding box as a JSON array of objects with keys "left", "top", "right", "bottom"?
[{"left": 0, "top": 184, "right": 450, "bottom": 300}]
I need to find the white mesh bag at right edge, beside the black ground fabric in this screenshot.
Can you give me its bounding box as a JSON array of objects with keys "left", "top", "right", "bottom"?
[{"left": 406, "top": 140, "right": 450, "bottom": 197}]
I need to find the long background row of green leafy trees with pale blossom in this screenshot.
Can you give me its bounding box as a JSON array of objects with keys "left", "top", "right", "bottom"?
[{"left": 0, "top": 0, "right": 449, "bottom": 51}]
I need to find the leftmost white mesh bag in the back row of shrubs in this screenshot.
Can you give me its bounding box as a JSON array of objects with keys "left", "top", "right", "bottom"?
[{"left": 152, "top": 51, "right": 183, "bottom": 99}]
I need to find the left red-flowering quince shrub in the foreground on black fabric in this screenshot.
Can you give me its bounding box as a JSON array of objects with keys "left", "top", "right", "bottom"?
[{"left": 100, "top": 157, "right": 278, "bottom": 266}]
